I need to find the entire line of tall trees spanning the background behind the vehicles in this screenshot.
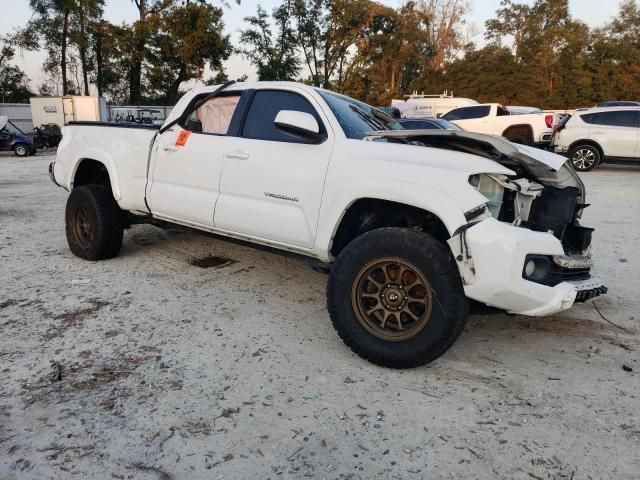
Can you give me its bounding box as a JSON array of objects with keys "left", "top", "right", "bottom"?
[{"left": 0, "top": 0, "right": 640, "bottom": 108}]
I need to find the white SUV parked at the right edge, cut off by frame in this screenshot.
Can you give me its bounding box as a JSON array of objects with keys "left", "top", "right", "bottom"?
[{"left": 551, "top": 107, "right": 640, "bottom": 172}]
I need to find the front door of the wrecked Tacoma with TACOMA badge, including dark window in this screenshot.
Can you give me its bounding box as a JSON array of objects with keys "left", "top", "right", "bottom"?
[{"left": 215, "top": 88, "right": 333, "bottom": 248}]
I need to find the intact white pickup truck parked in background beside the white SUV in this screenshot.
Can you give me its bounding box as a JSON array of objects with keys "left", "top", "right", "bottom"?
[{"left": 442, "top": 103, "right": 557, "bottom": 147}]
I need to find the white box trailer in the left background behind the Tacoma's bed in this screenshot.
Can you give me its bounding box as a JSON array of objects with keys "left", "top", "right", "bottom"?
[{"left": 29, "top": 95, "right": 108, "bottom": 128}]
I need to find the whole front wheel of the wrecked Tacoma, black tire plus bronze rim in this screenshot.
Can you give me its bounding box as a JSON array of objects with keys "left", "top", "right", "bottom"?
[{"left": 327, "top": 228, "right": 469, "bottom": 368}]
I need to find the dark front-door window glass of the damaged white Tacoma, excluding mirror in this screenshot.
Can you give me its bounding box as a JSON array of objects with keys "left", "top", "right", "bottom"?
[{"left": 242, "top": 90, "right": 323, "bottom": 143}]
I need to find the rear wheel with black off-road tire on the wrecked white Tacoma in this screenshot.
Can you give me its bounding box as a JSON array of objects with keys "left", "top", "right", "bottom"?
[{"left": 65, "top": 185, "right": 124, "bottom": 261}]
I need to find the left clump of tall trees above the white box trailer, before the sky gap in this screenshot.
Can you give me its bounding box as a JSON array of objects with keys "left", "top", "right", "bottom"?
[{"left": 0, "top": 0, "right": 233, "bottom": 104}]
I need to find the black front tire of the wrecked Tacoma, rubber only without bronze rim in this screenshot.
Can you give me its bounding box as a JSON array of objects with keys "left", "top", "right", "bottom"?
[{"left": 327, "top": 228, "right": 469, "bottom": 368}]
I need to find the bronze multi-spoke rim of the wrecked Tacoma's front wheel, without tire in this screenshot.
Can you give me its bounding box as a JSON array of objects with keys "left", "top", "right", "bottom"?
[{"left": 351, "top": 258, "right": 433, "bottom": 342}]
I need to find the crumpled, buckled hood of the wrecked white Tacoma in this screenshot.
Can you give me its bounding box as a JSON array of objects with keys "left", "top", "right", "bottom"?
[{"left": 364, "top": 130, "right": 585, "bottom": 199}]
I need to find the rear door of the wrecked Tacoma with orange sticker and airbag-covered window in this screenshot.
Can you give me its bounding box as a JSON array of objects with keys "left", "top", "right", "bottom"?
[{"left": 147, "top": 92, "right": 241, "bottom": 227}]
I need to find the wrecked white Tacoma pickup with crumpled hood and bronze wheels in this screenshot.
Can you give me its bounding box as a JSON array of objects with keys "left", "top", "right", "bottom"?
[{"left": 49, "top": 82, "right": 606, "bottom": 368}]
